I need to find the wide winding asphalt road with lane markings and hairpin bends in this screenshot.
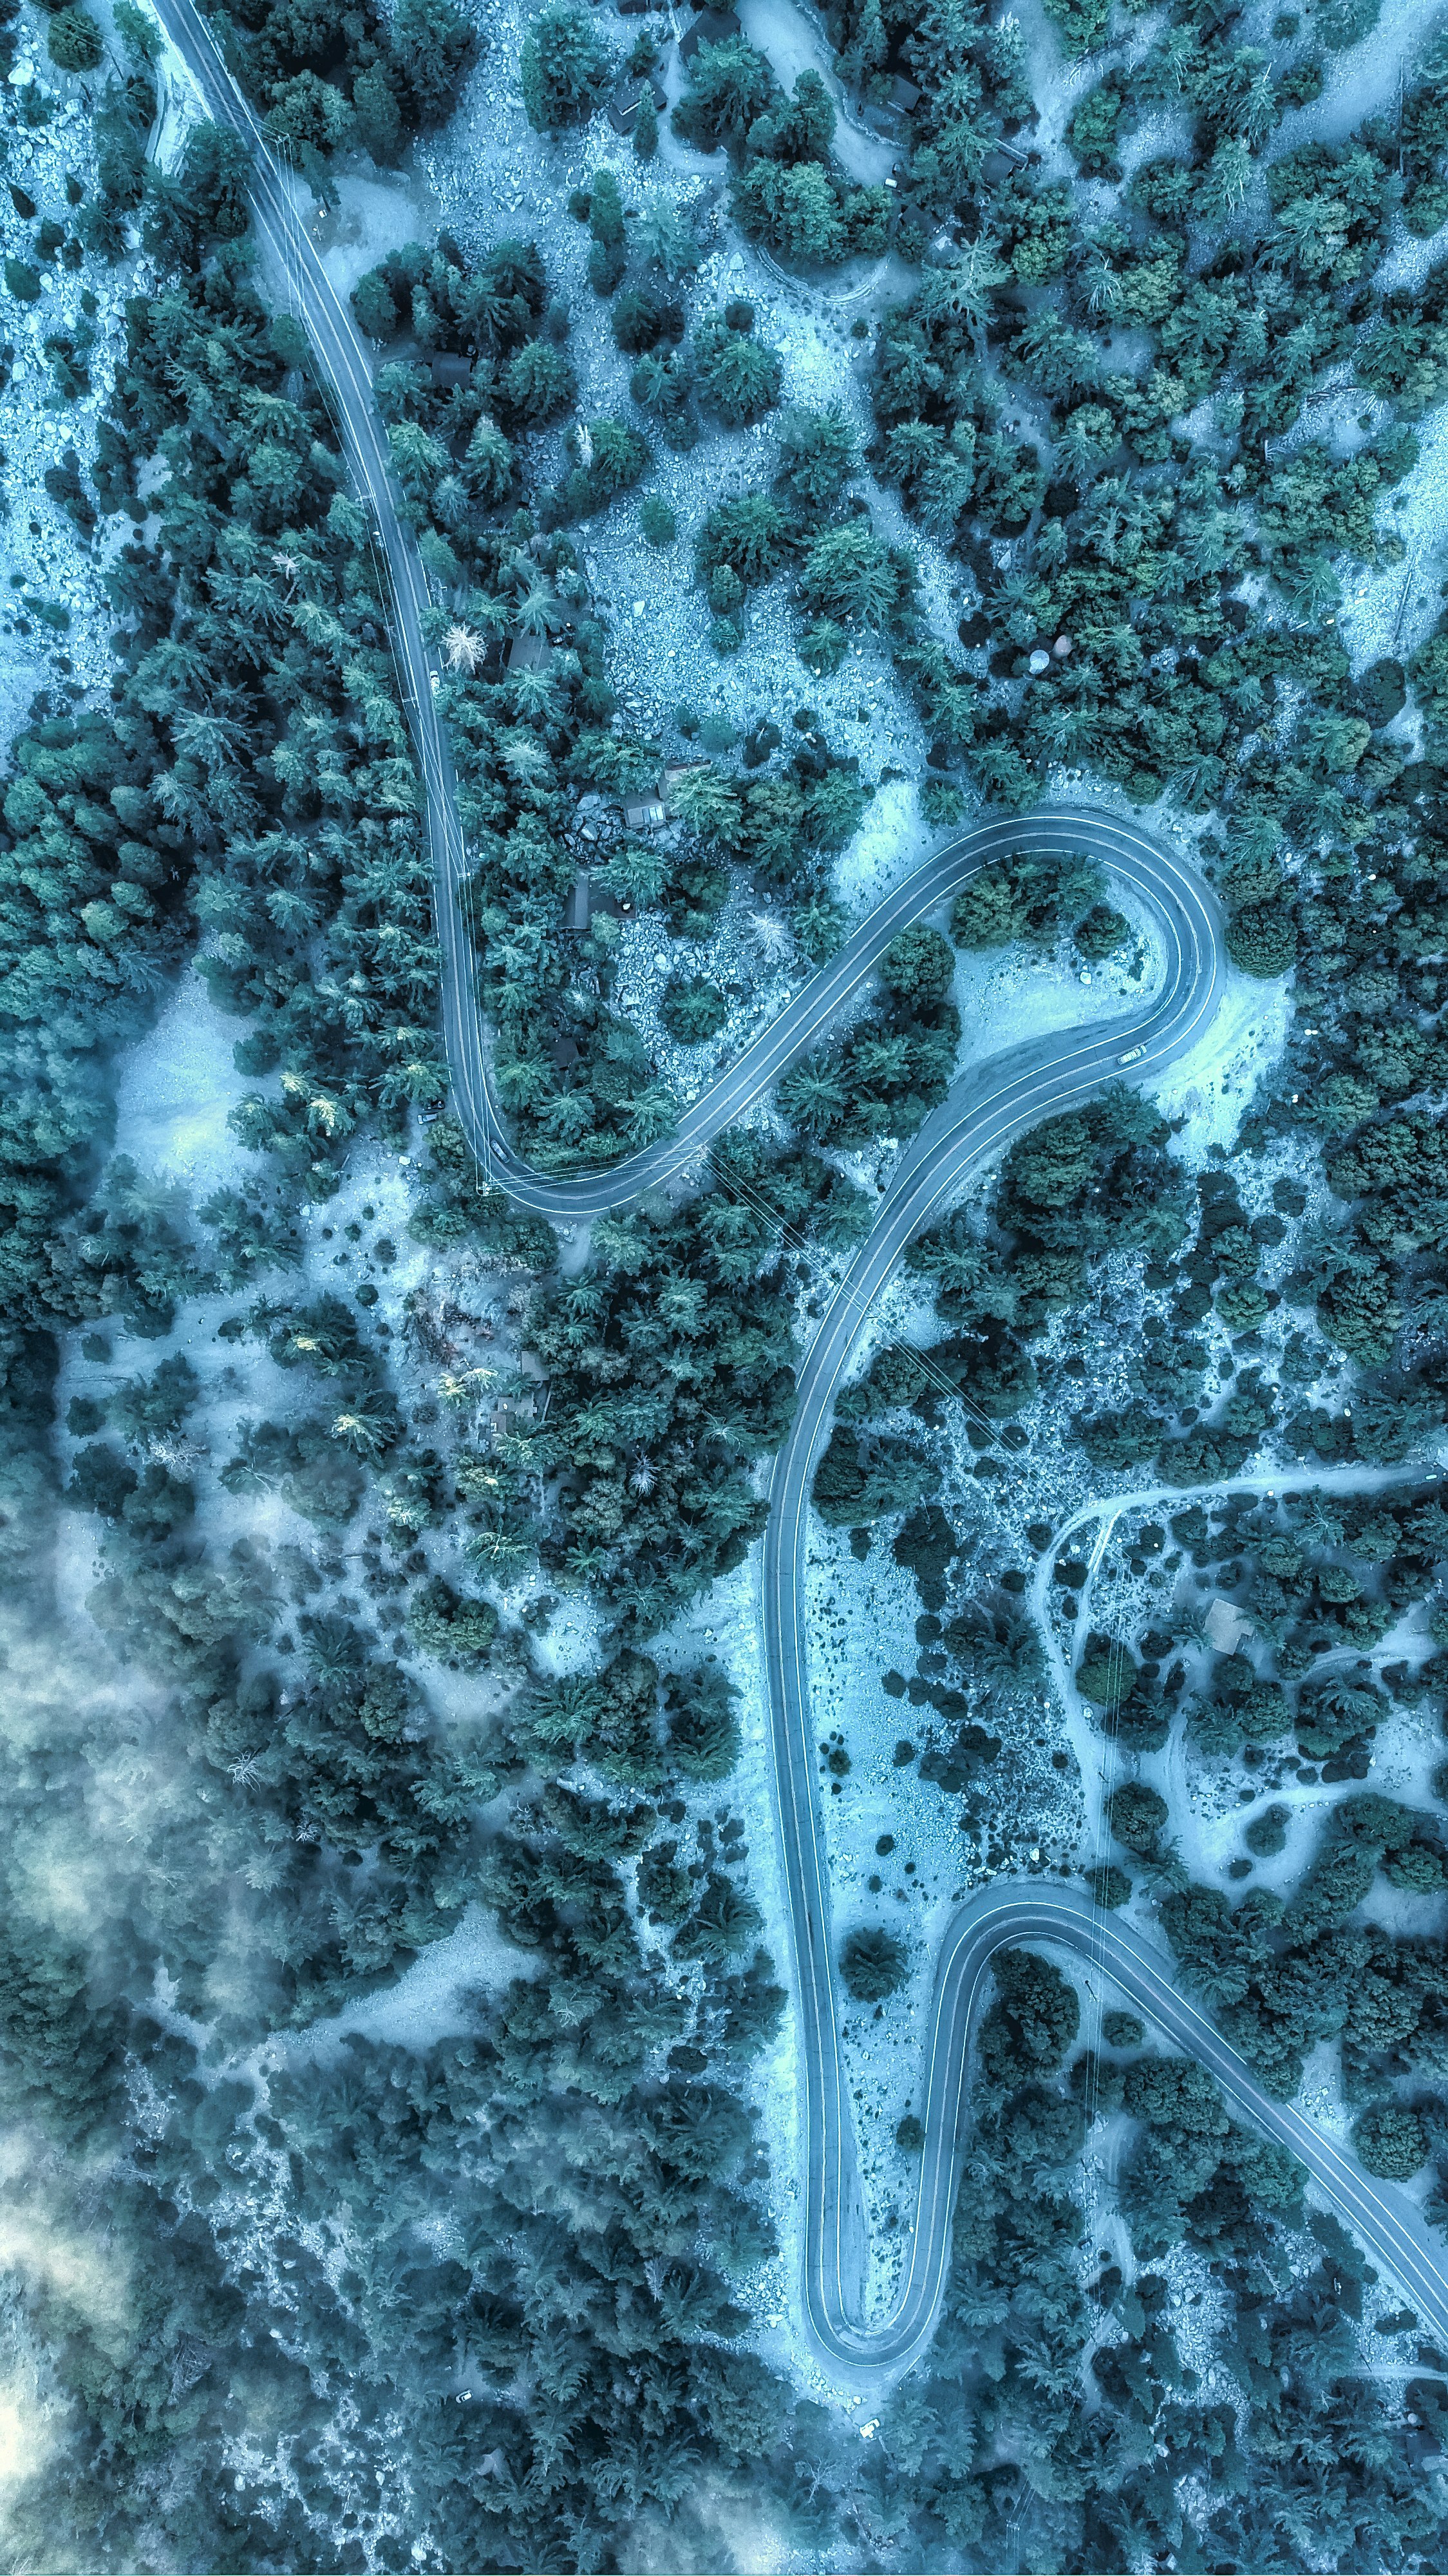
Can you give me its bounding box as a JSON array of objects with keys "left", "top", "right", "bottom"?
[{"left": 152, "top": 0, "right": 1448, "bottom": 2391}]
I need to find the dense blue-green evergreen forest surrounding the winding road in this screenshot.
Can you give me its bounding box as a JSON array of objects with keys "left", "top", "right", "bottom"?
[{"left": 0, "top": 0, "right": 1448, "bottom": 2568}]
